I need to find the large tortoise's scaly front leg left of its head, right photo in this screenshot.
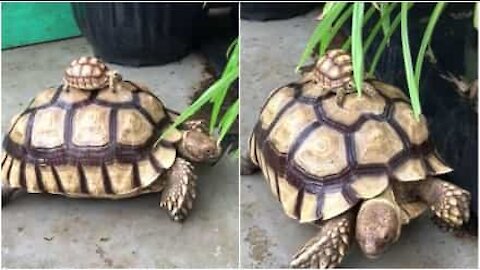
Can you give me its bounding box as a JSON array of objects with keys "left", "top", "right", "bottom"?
[{"left": 290, "top": 210, "right": 355, "bottom": 268}]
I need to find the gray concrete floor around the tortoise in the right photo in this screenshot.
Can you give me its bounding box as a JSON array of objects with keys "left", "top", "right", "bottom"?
[{"left": 240, "top": 10, "right": 477, "bottom": 268}]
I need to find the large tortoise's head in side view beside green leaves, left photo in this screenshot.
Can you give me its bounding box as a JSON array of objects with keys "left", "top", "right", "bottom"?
[{"left": 179, "top": 120, "right": 222, "bottom": 162}]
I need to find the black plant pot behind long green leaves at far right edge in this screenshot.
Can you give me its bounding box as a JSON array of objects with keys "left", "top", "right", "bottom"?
[{"left": 364, "top": 3, "right": 478, "bottom": 217}]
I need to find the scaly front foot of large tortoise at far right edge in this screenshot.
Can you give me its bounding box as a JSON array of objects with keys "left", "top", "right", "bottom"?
[{"left": 431, "top": 182, "right": 470, "bottom": 228}]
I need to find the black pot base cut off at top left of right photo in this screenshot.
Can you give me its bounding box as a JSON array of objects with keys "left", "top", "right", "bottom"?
[{"left": 240, "top": 3, "right": 318, "bottom": 21}]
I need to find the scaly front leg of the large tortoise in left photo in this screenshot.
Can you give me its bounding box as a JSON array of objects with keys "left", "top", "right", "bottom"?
[{"left": 160, "top": 158, "right": 196, "bottom": 221}]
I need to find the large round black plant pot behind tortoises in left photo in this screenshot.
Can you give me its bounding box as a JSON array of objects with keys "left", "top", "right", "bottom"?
[{"left": 72, "top": 3, "right": 204, "bottom": 66}]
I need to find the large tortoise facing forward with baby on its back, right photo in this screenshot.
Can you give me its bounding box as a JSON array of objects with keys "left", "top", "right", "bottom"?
[{"left": 242, "top": 50, "right": 470, "bottom": 268}]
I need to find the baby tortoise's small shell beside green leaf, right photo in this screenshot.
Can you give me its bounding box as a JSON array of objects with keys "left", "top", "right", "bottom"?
[{"left": 313, "top": 49, "right": 353, "bottom": 88}]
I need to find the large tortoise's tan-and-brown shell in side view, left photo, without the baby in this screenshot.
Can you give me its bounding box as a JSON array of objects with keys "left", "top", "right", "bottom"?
[{"left": 1, "top": 81, "right": 181, "bottom": 198}]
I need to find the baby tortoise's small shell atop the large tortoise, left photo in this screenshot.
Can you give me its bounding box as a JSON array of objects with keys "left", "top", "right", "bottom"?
[{"left": 64, "top": 56, "right": 109, "bottom": 90}]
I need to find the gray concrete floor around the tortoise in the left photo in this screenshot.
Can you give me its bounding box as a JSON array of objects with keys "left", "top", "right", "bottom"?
[{"left": 2, "top": 38, "right": 239, "bottom": 268}]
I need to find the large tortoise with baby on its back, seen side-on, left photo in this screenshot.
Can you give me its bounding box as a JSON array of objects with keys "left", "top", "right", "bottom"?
[{"left": 1, "top": 57, "right": 220, "bottom": 221}]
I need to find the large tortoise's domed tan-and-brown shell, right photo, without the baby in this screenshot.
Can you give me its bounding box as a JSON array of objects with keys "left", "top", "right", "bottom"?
[{"left": 249, "top": 77, "right": 451, "bottom": 222}]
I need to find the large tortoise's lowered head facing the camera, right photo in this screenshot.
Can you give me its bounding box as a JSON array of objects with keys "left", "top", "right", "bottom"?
[{"left": 355, "top": 198, "right": 402, "bottom": 259}]
